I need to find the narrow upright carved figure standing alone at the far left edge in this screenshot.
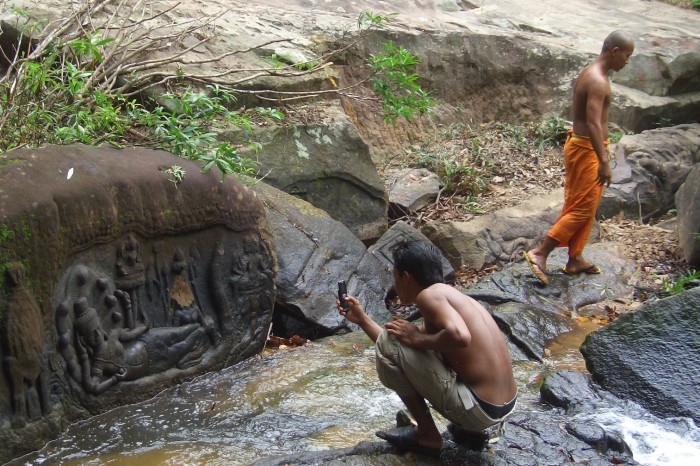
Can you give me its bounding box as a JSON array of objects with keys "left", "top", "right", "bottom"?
[{"left": 5, "top": 264, "right": 48, "bottom": 427}]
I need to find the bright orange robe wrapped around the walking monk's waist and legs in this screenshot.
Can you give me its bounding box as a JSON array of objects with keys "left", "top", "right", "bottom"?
[{"left": 547, "top": 130, "right": 610, "bottom": 256}]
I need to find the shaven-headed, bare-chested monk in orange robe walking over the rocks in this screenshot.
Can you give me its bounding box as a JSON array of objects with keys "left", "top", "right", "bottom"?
[{"left": 525, "top": 31, "right": 634, "bottom": 285}]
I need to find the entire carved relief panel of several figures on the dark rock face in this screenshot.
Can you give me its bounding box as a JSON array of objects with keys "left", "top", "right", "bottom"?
[{"left": 50, "top": 228, "right": 274, "bottom": 395}]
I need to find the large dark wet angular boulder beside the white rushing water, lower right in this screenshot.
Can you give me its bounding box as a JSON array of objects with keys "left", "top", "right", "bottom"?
[{"left": 580, "top": 288, "right": 700, "bottom": 422}]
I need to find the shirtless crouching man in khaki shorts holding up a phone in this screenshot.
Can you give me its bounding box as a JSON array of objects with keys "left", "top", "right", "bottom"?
[{"left": 337, "top": 241, "right": 517, "bottom": 457}]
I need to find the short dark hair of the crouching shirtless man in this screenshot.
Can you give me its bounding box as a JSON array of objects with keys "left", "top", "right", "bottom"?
[{"left": 392, "top": 241, "right": 445, "bottom": 288}]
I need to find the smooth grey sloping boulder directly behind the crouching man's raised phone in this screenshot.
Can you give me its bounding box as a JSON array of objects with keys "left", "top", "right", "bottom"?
[{"left": 252, "top": 182, "right": 393, "bottom": 338}]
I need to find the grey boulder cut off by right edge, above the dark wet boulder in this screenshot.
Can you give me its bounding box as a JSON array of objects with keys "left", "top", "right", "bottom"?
[{"left": 676, "top": 163, "right": 700, "bottom": 267}]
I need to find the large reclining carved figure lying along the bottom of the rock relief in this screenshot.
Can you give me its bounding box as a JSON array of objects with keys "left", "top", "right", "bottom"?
[{"left": 56, "top": 260, "right": 207, "bottom": 395}]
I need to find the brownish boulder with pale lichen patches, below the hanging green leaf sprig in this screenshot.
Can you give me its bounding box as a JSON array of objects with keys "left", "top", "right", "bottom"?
[{"left": 242, "top": 104, "right": 388, "bottom": 241}]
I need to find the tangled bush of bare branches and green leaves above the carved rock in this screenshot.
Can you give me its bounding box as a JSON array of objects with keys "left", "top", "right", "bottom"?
[{"left": 0, "top": 0, "right": 432, "bottom": 178}]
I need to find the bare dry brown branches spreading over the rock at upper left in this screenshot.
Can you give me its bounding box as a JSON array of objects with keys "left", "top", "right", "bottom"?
[{"left": 0, "top": 0, "right": 388, "bottom": 115}]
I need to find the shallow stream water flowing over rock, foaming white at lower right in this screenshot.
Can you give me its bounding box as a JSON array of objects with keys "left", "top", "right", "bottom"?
[{"left": 8, "top": 325, "right": 700, "bottom": 466}]
